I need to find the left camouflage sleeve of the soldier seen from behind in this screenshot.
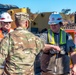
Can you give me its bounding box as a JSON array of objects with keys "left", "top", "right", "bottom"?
[{"left": 0, "top": 38, "right": 8, "bottom": 69}]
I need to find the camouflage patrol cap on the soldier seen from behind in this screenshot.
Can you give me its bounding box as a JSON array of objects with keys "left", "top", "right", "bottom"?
[{"left": 15, "top": 12, "right": 29, "bottom": 21}]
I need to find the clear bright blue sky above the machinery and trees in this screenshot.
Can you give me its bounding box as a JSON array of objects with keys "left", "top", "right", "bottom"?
[{"left": 0, "top": 0, "right": 76, "bottom": 13}]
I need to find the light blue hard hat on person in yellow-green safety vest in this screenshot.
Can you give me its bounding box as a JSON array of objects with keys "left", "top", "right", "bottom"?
[{"left": 48, "top": 12, "right": 63, "bottom": 25}]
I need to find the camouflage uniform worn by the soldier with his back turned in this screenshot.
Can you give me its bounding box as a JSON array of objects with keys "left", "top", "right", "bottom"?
[{"left": 0, "top": 14, "right": 44, "bottom": 75}]
